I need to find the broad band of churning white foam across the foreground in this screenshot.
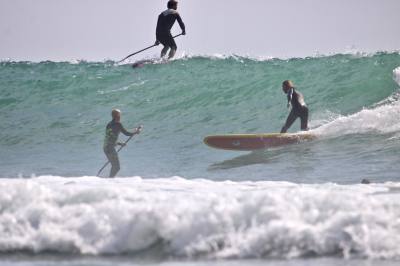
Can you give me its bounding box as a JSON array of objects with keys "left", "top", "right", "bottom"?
[{"left": 0, "top": 176, "right": 400, "bottom": 259}]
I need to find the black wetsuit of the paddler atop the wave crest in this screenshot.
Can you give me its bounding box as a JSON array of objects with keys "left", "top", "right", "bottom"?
[{"left": 156, "top": 9, "right": 185, "bottom": 50}]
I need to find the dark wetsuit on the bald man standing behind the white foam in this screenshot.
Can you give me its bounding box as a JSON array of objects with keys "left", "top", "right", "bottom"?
[{"left": 103, "top": 120, "right": 134, "bottom": 177}]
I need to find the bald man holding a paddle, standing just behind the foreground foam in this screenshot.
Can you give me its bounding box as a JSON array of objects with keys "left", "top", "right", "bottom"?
[{"left": 103, "top": 109, "right": 140, "bottom": 177}]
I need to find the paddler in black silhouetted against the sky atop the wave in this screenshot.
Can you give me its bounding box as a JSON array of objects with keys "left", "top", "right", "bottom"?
[{"left": 155, "top": 0, "right": 186, "bottom": 59}]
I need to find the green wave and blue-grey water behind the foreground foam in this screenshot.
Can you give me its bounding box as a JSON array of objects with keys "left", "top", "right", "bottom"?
[{"left": 0, "top": 52, "right": 400, "bottom": 183}]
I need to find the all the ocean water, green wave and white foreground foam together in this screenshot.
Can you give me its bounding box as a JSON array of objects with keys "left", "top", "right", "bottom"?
[{"left": 0, "top": 52, "right": 400, "bottom": 266}]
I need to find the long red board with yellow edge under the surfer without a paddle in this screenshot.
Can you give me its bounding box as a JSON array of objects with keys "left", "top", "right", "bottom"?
[{"left": 204, "top": 133, "right": 316, "bottom": 151}]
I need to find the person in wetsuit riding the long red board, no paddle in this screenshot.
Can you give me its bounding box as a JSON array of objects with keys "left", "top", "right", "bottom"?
[{"left": 281, "top": 80, "right": 308, "bottom": 133}]
